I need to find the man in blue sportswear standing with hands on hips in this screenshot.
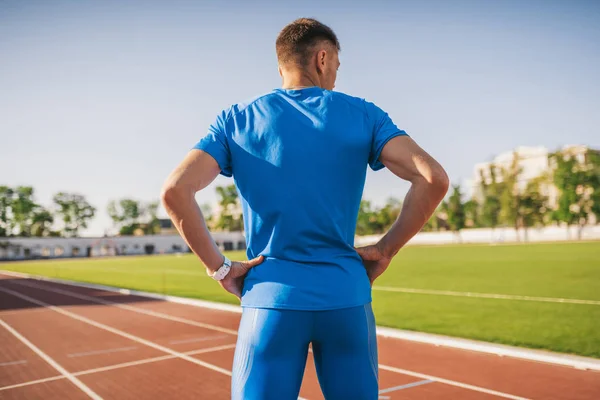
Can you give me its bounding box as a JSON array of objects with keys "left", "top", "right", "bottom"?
[{"left": 162, "top": 18, "right": 448, "bottom": 400}]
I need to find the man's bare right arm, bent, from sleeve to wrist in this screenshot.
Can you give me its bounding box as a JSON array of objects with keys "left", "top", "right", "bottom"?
[{"left": 378, "top": 136, "right": 449, "bottom": 258}]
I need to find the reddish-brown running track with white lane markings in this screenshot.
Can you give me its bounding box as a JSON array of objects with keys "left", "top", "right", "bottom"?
[{"left": 0, "top": 275, "right": 600, "bottom": 400}]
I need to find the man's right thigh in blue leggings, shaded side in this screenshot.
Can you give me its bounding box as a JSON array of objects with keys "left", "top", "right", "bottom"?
[{"left": 313, "top": 304, "right": 378, "bottom": 400}]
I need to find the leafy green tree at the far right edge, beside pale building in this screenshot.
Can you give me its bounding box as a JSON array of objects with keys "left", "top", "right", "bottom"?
[{"left": 550, "top": 151, "right": 600, "bottom": 239}]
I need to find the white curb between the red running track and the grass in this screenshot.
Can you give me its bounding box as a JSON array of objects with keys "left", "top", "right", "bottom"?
[{"left": 0, "top": 270, "right": 600, "bottom": 371}]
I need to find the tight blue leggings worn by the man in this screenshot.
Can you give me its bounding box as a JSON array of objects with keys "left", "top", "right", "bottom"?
[{"left": 231, "top": 304, "right": 378, "bottom": 400}]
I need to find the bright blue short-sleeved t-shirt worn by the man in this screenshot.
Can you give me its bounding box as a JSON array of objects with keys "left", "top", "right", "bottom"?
[{"left": 195, "top": 87, "right": 406, "bottom": 310}]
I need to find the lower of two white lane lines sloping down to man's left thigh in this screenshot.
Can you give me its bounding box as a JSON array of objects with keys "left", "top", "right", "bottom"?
[{"left": 0, "top": 287, "right": 231, "bottom": 379}]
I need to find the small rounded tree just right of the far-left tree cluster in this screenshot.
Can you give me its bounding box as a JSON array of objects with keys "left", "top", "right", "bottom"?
[{"left": 53, "top": 192, "right": 96, "bottom": 237}]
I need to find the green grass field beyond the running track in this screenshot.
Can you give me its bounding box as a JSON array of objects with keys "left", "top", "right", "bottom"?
[{"left": 0, "top": 242, "right": 600, "bottom": 358}]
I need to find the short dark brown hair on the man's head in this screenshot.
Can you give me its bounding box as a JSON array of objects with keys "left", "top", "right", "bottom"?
[{"left": 275, "top": 18, "right": 340, "bottom": 66}]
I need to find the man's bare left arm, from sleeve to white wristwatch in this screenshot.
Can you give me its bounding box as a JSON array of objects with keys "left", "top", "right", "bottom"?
[{"left": 161, "top": 150, "right": 223, "bottom": 271}]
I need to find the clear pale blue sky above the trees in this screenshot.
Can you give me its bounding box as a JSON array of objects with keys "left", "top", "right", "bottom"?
[{"left": 0, "top": 0, "right": 600, "bottom": 235}]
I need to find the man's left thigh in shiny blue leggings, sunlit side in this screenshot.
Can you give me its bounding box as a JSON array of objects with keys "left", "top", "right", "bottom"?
[{"left": 231, "top": 308, "right": 312, "bottom": 400}]
